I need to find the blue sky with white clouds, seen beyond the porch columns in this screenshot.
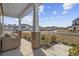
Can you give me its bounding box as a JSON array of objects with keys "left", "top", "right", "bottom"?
[{"left": 4, "top": 3, "right": 79, "bottom": 27}]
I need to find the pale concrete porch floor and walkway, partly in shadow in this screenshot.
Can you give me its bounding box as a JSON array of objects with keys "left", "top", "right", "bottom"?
[{"left": 1, "top": 38, "right": 71, "bottom": 56}]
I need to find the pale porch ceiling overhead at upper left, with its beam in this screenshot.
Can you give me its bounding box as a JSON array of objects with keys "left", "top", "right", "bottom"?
[{"left": 3, "top": 3, "right": 32, "bottom": 18}]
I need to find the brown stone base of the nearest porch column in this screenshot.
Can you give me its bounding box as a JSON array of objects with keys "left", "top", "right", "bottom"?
[{"left": 32, "top": 32, "right": 40, "bottom": 49}]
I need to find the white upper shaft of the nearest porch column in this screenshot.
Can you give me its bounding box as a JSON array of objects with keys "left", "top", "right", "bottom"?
[{"left": 33, "top": 4, "right": 39, "bottom": 32}]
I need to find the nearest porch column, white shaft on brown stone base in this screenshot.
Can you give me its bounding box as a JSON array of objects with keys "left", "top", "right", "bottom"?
[{"left": 32, "top": 4, "right": 40, "bottom": 48}]
